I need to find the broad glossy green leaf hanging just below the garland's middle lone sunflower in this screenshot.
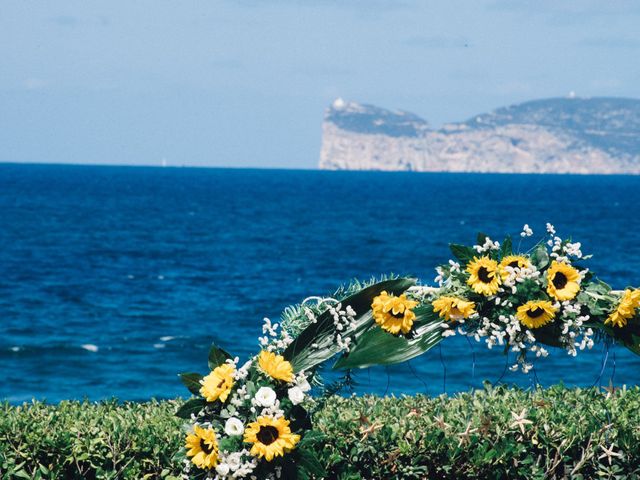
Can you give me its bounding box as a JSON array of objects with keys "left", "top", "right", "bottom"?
[{"left": 333, "top": 305, "right": 443, "bottom": 369}]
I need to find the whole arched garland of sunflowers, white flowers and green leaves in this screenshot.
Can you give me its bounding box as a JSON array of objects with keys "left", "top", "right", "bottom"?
[{"left": 177, "top": 224, "right": 640, "bottom": 480}]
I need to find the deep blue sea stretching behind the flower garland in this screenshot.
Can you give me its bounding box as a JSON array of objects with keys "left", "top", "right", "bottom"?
[{"left": 0, "top": 164, "right": 640, "bottom": 402}]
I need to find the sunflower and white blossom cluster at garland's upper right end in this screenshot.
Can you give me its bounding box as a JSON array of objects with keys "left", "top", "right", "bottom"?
[{"left": 420, "top": 224, "right": 640, "bottom": 373}]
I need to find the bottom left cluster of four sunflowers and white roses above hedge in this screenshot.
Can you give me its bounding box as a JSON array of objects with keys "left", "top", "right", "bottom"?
[{"left": 178, "top": 319, "right": 315, "bottom": 480}]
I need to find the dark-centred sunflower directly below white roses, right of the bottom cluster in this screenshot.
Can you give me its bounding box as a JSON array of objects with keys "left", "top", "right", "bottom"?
[{"left": 244, "top": 416, "right": 300, "bottom": 462}]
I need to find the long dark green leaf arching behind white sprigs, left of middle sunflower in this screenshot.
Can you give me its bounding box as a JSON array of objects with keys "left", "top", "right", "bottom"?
[{"left": 283, "top": 278, "right": 416, "bottom": 372}]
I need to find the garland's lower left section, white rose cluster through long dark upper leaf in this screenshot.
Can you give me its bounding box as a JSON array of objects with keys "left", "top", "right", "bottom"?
[{"left": 177, "top": 279, "right": 412, "bottom": 480}]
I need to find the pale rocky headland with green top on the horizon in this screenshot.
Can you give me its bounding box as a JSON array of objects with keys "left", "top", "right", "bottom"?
[{"left": 320, "top": 98, "right": 640, "bottom": 174}]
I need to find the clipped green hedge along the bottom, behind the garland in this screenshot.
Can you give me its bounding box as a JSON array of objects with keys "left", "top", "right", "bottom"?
[{"left": 0, "top": 387, "right": 640, "bottom": 480}]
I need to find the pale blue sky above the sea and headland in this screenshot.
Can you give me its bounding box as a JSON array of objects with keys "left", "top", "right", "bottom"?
[{"left": 0, "top": 0, "right": 640, "bottom": 168}]
